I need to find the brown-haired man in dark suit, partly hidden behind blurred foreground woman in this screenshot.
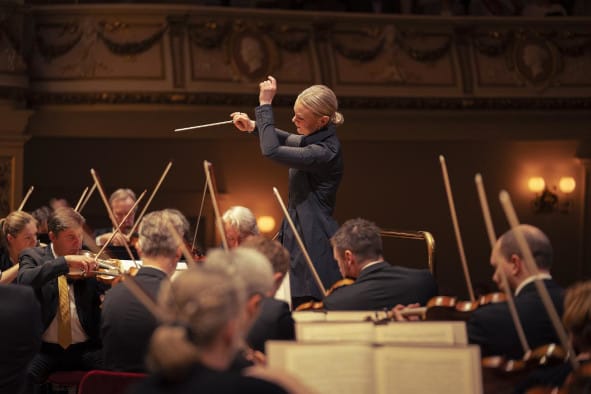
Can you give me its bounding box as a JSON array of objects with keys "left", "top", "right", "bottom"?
[{"left": 241, "top": 235, "right": 295, "bottom": 353}]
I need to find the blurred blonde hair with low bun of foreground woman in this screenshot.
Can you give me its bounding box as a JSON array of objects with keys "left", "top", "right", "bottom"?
[{"left": 147, "top": 267, "right": 245, "bottom": 379}]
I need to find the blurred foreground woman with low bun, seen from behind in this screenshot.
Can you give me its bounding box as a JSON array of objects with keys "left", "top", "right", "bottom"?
[{"left": 132, "top": 264, "right": 307, "bottom": 394}]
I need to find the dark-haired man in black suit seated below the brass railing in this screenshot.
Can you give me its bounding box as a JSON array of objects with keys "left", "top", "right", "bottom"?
[{"left": 323, "top": 218, "right": 437, "bottom": 310}]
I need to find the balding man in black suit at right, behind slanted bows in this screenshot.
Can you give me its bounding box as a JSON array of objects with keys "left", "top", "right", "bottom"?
[{"left": 467, "top": 225, "right": 563, "bottom": 359}]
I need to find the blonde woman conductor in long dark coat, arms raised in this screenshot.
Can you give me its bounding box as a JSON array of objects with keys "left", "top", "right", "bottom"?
[{"left": 230, "top": 76, "right": 344, "bottom": 307}]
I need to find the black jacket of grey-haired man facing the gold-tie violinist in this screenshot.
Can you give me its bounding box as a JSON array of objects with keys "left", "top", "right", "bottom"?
[{"left": 101, "top": 267, "right": 166, "bottom": 372}]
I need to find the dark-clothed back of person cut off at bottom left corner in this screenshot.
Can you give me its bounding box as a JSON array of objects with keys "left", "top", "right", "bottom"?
[{"left": 0, "top": 284, "right": 43, "bottom": 394}]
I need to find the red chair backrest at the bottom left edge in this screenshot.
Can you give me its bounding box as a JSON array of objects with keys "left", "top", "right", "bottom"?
[{"left": 78, "top": 370, "right": 146, "bottom": 394}]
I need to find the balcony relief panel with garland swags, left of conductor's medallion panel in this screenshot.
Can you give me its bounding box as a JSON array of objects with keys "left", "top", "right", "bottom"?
[{"left": 32, "top": 16, "right": 167, "bottom": 79}]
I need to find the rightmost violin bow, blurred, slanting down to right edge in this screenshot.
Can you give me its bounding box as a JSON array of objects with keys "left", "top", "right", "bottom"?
[{"left": 499, "top": 190, "right": 579, "bottom": 370}]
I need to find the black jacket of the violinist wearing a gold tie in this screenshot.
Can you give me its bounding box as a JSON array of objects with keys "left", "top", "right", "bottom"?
[{"left": 17, "top": 245, "right": 104, "bottom": 344}]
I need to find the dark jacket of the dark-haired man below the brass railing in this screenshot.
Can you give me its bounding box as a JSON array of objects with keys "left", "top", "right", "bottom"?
[{"left": 324, "top": 261, "right": 437, "bottom": 310}]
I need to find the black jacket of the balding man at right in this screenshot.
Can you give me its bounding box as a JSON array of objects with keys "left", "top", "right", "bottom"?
[{"left": 466, "top": 280, "right": 564, "bottom": 358}]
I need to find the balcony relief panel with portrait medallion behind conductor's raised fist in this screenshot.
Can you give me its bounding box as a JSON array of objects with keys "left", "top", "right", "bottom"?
[{"left": 188, "top": 19, "right": 315, "bottom": 83}]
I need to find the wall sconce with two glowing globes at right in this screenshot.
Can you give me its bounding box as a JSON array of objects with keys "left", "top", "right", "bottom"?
[{"left": 527, "top": 176, "right": 577, "bottom": 213}]
